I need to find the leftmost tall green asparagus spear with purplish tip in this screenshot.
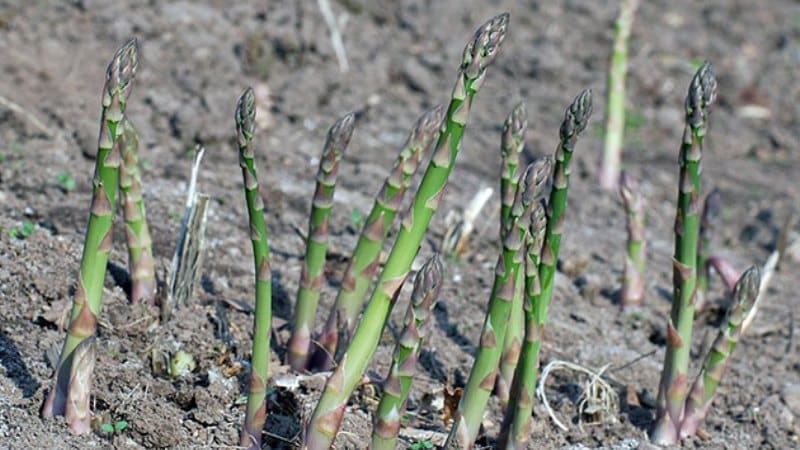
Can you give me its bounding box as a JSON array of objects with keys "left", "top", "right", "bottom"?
[{"left": 42, "top": 39, "right": 138, "bottom": 432}]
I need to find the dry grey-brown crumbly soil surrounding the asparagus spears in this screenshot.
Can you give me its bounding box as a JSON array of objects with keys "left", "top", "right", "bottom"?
[{"left": 0, "top": 0, "right": 800, "bottom": 449}]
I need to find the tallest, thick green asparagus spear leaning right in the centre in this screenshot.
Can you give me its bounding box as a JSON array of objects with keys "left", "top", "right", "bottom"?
[{"left": 303, "top": 14, "right": 509, "bottom": 450}]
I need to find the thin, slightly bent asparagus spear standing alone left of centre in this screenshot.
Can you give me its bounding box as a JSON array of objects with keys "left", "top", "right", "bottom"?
[{"left": 234, "top": 88, "right": 272, "bottom": 449}]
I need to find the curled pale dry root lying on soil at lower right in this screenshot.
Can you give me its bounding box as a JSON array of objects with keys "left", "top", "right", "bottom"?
[{"left": 536, "top": 360, "right": 619, "bottom": 431}]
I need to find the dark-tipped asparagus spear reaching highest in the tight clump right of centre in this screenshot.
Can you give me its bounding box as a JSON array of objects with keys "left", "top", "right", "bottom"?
[{"left": 533, "top": 89, "right": 592, "bottom": 327}]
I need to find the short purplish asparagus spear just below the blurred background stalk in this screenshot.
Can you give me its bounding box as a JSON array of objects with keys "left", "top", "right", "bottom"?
[{"left": 619, "top": 172, "right": 647, "bottom": 310}]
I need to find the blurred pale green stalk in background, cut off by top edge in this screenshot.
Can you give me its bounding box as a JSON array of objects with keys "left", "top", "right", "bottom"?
[{"left": 600, "top": 0, "right": 639, "bottom": 191}]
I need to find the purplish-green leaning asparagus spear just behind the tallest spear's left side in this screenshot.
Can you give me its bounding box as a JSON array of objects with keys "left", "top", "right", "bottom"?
[{"left": 312, "top": 106, "right": 444, "bottom": 370}]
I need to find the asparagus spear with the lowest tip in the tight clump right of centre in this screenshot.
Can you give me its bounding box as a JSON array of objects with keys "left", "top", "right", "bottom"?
[{"left": 498, "top": 203, "right": 547, "bottom": 450}]
